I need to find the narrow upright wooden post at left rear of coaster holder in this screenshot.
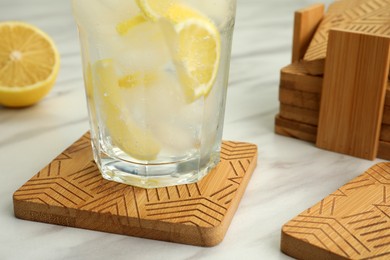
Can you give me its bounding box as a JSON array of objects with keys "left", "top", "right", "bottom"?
[{"left": 292, "top": 4, "right": 325, "bottom": 62}]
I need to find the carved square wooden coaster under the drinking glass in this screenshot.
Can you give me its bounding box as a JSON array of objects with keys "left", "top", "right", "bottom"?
[{"left": 13, "top": 134, "right": 257, "bottom": 246}]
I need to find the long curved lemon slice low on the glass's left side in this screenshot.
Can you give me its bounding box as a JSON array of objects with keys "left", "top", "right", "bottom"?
[{"left": 94, "top": 60, "right": 161, "bottom": 161}]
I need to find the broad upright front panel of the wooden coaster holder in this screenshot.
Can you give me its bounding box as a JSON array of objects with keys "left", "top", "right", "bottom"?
[{"left": 316, "top": 30, "right": 390, "bottom": 160}]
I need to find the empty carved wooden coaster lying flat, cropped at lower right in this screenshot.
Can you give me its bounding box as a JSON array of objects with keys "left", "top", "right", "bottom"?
[{"left": 281, "top": 163, "right": 390, "bottom": 259}]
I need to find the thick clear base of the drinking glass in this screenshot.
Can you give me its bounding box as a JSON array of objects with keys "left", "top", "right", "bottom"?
[{"left": 97, "top": 152, "right": 220, "bottom": 188}]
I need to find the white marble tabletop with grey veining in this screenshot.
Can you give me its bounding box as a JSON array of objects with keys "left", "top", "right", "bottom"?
[{"left": 0, "top": 0, "right": 384, "bottom": 259}]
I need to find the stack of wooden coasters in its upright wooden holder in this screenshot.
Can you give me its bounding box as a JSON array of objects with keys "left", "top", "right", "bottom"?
[{"left": 275, "top": 0, "right": 390, "bottom": 160}]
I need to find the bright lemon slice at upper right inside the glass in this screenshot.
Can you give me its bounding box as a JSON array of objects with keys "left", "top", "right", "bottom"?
[{"left": 137, "top": 0, "right": 221, "bottom": 102}]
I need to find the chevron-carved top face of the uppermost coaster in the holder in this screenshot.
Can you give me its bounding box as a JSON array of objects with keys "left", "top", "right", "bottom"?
[{"left": 304, "top": 0, "right": 390, "bottom": 61}]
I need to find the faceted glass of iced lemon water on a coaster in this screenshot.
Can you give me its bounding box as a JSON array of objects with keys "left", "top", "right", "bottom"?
[{"left": 73, "top": 0, "right": 236, "bottom": 188}]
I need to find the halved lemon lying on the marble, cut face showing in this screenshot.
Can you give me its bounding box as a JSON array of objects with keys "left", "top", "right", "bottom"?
[{"left": 0, "top": 22, "right": 60, "bottom": 107}]
